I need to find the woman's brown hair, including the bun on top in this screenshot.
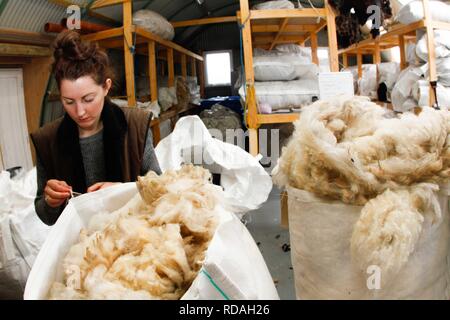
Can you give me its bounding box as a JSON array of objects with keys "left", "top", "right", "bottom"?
[{"left": 53, "top": 31, "right": 113, "bottom": 87}]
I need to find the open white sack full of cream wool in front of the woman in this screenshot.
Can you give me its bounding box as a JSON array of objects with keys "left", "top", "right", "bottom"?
[{"left": 25, "top": 165, "right": 278, "bottom": 299}]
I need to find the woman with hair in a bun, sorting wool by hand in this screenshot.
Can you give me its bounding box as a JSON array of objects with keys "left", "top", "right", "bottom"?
[{"left": 31, "top": 31, "right": 160, "bottom": 225}]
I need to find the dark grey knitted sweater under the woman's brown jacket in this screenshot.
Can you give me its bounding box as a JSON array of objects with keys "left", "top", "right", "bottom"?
[{"left": 34, "top": 130, "right": 161, "bottom": 222}]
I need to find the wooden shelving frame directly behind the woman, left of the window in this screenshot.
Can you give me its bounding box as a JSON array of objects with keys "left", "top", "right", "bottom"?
[{"left": 82, "top": 0, "right": 204, "bottom": 144}]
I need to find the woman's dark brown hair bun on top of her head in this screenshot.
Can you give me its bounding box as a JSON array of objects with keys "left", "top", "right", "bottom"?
[{"left": 54, "top": 31, "right": 98, "bottom": 61}]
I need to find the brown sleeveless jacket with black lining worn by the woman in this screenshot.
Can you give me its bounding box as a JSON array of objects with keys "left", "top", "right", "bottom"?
[{"left": 31, "top": 99, "right": 151, "bottom": 193}]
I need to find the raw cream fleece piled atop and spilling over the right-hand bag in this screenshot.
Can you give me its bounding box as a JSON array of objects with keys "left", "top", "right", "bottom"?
[{"left": 273, "top": 96, "right": 450, "bottom": 282}]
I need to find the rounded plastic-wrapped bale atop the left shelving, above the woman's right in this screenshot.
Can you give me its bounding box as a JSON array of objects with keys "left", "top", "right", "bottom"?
[{"left": 133, "top": 9, "right": 175, "bottom": 41}]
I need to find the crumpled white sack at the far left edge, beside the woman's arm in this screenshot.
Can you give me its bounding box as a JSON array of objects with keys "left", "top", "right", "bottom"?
[{"left": 0, "top": 168, "right": 50, "bottom": 299}]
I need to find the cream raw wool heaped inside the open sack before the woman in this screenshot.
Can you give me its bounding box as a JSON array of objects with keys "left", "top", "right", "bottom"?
[{"left": 49, "top": 165, "right": 222, "bottom": 299}]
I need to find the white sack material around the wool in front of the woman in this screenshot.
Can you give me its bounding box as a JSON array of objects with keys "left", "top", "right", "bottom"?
[{"left": 24, "top": 183, "right": 278, "bottom": 300}]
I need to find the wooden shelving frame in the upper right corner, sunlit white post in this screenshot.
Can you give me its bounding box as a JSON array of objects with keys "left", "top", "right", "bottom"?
[{"left": 339, "top": 0, "right": 450, "bottom": 106}]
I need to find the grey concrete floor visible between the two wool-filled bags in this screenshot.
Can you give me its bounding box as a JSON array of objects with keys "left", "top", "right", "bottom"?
[{"left": 244, "top": 187, "right": 295, "bottom": 300}]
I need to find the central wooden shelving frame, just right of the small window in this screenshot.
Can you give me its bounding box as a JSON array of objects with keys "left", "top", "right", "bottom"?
[{"left": 237, "top": 0, "right": 339, "bottom": 155}]
